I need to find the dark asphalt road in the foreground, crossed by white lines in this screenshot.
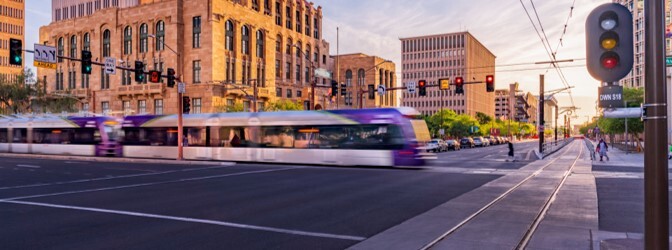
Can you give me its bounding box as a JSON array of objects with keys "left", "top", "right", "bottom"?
[{"left": 0, "top": 155, "right": 504, "bottom": 249}]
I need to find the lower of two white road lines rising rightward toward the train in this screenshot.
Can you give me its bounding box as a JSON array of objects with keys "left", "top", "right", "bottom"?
[{"left": 0, "top": 167, "right": 299, "bottom": 202}]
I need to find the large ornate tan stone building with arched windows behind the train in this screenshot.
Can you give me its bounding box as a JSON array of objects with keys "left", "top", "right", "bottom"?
[{"left": 38, "top": 0, "right": 329, "bottom": 114}]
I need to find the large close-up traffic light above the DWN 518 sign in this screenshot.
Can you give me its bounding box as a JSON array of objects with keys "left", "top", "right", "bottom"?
[{"left": 586, "top": 3, "right": 634, "bottom": 83}]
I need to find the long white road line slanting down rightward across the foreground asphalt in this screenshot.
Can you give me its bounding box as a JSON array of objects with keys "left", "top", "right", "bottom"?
[{"left": 0, "top": 200, "right": 366, "bottom": 241}]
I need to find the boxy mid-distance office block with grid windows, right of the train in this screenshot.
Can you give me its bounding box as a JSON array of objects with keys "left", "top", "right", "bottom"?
[{"left": 401, "top": 32, "right": 495, "bottom": 116}]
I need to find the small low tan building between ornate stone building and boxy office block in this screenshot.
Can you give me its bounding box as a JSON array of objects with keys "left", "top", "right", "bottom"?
[{"left": 332, "top": 53, "right": 400, "bottom": 109}]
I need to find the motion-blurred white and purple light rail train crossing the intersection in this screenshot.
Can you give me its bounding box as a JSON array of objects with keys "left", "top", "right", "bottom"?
[{"left": 0, "top": 108, "right": 429, "bottom": 166}]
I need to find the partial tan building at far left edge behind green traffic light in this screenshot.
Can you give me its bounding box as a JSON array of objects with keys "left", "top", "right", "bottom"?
[{"left": 0, "top": 0, "right": 26, "bottom": 80}]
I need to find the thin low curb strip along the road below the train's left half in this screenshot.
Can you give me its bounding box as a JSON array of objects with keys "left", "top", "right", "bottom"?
[{"left": 0, "top": 153, "right": 236, "bottom": 166}]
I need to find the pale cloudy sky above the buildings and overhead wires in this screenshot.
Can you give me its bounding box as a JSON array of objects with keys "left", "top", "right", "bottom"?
[{"left": 26, "top": 0, "right": 611, "bottom": 122}]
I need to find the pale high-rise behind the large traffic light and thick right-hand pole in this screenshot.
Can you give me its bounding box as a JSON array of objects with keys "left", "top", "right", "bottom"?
[{"left": 613, "top": 0, "right": 672, "bottom": 88}]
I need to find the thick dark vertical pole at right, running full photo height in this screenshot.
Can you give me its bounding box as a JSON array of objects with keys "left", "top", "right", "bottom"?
[{"left": 644, "top": 0, "right": 670, "bottom": 249}]
